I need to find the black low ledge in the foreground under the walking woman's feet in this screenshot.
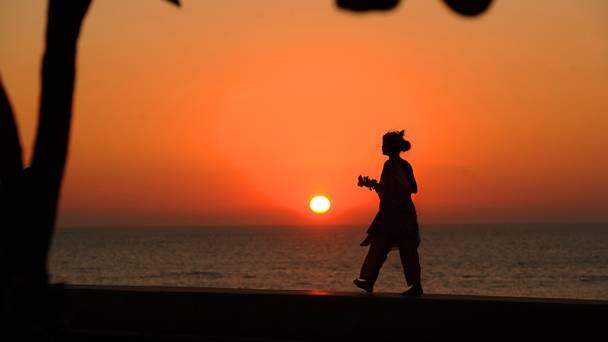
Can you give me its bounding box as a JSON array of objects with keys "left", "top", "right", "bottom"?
[{"left": 58, "top": 286, "right": 608, "bottom": 341}]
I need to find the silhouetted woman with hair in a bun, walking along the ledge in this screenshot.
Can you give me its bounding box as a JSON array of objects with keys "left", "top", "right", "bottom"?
[{"left": 353, "top": 131, "right": 423, "bottom": 296}]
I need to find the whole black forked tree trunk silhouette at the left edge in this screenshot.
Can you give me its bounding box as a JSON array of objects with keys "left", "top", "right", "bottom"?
[{"left": 0, "top": 0, "right": 91, "bottom": 336}]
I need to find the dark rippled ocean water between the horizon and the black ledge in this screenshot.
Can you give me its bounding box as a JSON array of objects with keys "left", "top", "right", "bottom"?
[{"left": 49, "top": 225, "right": 608, "bottom": 300}]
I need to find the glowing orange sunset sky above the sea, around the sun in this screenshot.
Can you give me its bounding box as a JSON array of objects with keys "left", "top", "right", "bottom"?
[{"left": 0, "top": 0, "right": 608, "bottom": 226}]
